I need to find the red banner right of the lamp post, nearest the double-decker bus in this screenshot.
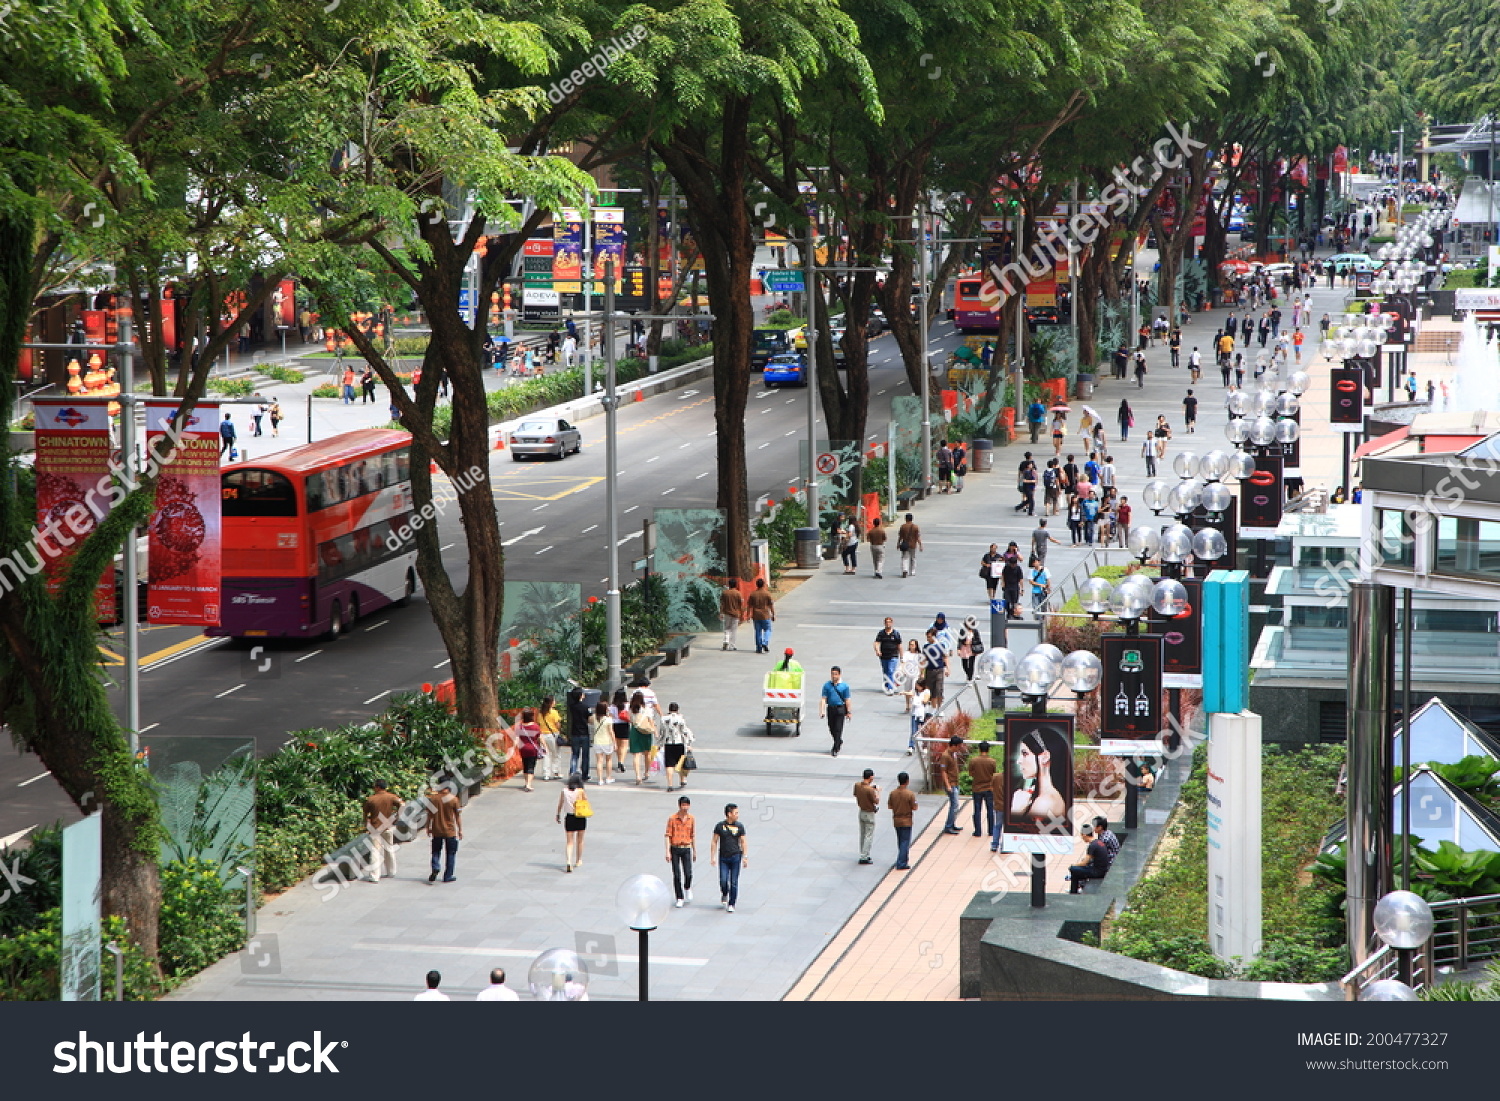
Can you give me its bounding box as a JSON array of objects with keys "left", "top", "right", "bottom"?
[{"left": 146, "top": 399, "right": 222, "bottom": 627}]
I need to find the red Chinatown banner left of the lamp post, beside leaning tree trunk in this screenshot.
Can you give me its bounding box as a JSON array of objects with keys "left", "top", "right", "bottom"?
[{"left": 31, "top": 398, "right": 114, "bottom": 623}]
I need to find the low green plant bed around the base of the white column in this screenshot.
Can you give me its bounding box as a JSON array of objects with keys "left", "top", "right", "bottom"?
[{"left": 1104, "top": 746, "right": 1347, "bottom": 983}]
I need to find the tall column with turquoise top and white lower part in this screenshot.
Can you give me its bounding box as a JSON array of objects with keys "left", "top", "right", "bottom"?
[{"left": 1203, "top": 570, "right": 1262, "bottom": 960}]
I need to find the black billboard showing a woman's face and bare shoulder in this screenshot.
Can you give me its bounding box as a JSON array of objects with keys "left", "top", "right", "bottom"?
[{"left": 1001, "top": 714, "right": 1073, "bottom": 852}]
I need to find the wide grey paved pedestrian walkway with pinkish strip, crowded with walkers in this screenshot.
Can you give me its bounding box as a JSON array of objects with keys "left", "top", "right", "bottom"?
[{"left": 174, "top": 262, "right": 1368, "bottom": 1001}]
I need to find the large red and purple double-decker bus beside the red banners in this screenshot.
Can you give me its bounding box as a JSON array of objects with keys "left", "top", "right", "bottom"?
[{"left": 209, "top": 429, "right": 417, "bottom": 638}]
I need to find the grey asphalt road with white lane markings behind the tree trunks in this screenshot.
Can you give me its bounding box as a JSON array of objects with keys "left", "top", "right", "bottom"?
[{"left": 0, "top": 323, "right": 957, "bottom": 848}]
